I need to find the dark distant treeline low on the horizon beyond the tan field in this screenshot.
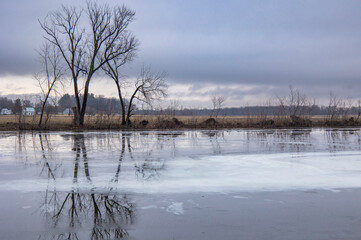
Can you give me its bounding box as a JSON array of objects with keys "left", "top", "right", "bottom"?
[{"left": 0, "top": 94, "right": 361, "bottom": 116}]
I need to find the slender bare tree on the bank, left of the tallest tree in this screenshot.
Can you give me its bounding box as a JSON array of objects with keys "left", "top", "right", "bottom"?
[{"left": 34, "top": 43, "right": 63, "bottom": 127}]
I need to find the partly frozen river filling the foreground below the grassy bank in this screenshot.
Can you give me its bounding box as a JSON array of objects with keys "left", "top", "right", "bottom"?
[{"left": 0, "top": 129, "right": 361, "bottom": 239}]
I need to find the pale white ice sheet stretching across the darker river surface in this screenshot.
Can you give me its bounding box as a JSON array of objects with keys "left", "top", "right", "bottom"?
[{"left": 0, "top": 151, "right": 361, "bottom": 193}]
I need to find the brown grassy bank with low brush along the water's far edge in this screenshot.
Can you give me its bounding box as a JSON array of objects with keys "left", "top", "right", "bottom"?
[{"left": 0, "top": 115, "right": 361, "bottom": 131}]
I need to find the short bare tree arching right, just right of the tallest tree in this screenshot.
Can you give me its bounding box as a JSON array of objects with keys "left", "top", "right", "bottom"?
[{"left": 126, "top": 66, "right": 167, "bottom": 125}]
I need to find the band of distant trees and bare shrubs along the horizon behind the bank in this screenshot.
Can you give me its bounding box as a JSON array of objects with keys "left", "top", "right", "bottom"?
[{"left": 0, "top": 87, "right": 361, "bottom": 120}]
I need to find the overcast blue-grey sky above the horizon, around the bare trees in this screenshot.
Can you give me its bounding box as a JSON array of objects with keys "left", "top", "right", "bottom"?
[{"left": 0, "top": 0, "right": 361, "bottom": 107}]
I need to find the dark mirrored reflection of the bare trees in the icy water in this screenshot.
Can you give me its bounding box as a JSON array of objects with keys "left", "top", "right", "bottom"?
[{"left": 39, "top": 134, "right": 135, "bottom": 239}]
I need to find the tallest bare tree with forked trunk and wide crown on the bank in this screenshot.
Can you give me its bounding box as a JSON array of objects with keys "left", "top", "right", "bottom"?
[{"left": 40, "top": 1, "right": 138, "bottom": 125}]
